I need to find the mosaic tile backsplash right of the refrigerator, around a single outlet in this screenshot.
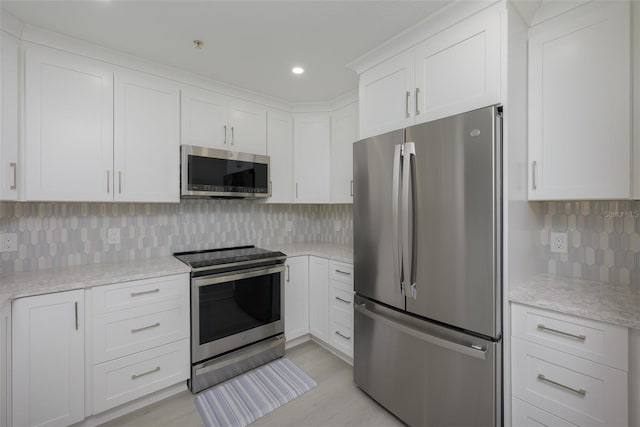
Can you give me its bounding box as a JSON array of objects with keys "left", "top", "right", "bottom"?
[{"left": 540, "top": 201, "right": 640, "bottom": 286}]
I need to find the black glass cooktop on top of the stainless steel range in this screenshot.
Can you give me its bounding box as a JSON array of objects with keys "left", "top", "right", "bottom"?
[{"left": 173, "top": 246, "right": 286, "bottom": 269}]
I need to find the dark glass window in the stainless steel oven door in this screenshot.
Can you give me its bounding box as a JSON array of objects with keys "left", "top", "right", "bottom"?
[{"left": 198, "top": 273, "right": 281, "bottom": 345}]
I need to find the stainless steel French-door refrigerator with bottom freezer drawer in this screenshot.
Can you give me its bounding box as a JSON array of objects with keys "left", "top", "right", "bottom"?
[{"left": 353, "top": 106, "right": 503, "bottom": 427}]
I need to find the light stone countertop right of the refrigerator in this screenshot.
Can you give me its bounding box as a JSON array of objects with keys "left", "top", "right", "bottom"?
[{"left": 509, "top": 274, "right": 640, "bottom": 329}]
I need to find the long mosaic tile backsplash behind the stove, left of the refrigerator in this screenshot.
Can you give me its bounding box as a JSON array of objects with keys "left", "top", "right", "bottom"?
[{"left": 0, "top": 200, "right": 353, "bottom": 274}]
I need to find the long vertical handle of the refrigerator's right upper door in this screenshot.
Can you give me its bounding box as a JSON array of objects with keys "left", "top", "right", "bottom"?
[{"left": 402, "top": 142, "right": 417, "bottom": 299}]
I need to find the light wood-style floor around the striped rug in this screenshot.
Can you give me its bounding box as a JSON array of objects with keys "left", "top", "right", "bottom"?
[{"left": 100, "top": 342, "right": 403, "bottom": 427}]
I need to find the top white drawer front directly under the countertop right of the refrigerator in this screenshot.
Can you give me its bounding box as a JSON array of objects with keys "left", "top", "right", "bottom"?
[{"left": 511, "top": 304, "right": 629, "bottom": 371}]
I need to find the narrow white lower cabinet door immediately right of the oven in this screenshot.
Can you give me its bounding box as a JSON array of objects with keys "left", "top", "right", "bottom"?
[{"left": 284, "top": 256, "right": 309, "bottom": 341}]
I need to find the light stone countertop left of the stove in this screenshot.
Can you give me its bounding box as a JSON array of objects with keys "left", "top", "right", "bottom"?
[{"left": 0, "top": 256, "right": 191, "bottom": 304}]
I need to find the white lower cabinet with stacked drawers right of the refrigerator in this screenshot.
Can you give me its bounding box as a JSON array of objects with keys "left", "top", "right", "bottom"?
[{"left": 511, "top": 304, "right": 629, "bottom": 427}]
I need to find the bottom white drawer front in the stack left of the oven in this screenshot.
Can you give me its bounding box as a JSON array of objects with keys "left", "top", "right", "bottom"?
[{"left": 93, "top": 339, "right": 189, "bottom": 414}]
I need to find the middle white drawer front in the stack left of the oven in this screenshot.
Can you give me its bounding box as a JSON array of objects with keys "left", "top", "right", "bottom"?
[{"left": 92, "top": 301, "right": 189, "bottom": 363}]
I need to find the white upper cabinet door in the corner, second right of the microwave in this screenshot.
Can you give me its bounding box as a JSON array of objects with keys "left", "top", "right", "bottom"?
[{"left": 293, "top": 113, "right": 331, "bottom": 203}]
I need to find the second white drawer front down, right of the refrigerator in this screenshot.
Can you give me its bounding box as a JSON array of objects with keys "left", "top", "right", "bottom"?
[{"left": 512, "top": 338, "right": 628, "bottom": 427}]
